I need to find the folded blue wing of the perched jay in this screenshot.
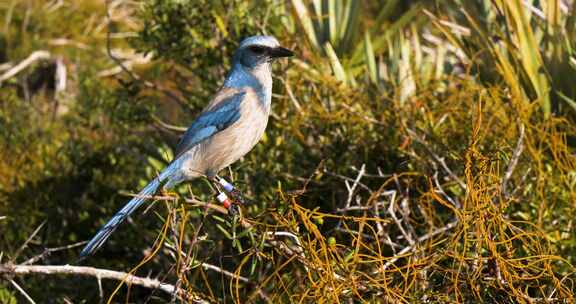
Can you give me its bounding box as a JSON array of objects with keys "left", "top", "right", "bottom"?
[{"left": 174, "top": 92, "right": 246, "bottom": 159}]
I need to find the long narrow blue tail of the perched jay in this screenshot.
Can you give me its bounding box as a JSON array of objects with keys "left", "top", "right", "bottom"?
[{"left": 80, "top": 174, "right": 164, "bottom": 259}]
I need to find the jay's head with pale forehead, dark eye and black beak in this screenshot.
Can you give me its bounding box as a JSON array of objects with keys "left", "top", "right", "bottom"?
[{"left": 234, "top": 36, "right": 294, "bottom": 69}]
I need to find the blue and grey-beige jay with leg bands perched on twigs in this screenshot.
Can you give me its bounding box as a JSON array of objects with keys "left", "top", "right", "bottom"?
[{"left": 80, "top": 35, "right": 294, "bottom": 259}]
